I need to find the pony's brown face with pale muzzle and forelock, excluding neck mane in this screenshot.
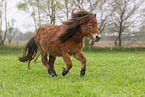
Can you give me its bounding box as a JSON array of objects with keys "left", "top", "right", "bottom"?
[{"left": 72, "top": 9, "right": 101, "bottom": 42}]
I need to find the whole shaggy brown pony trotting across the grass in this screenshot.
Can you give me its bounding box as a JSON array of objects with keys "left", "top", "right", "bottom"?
[{"left": 19, "top": 9, "right": 101, "bottom": 76}]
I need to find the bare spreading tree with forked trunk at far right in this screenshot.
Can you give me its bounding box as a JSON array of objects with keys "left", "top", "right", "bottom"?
[{"left": 111, "top": 0, "right": 143, "bottom": 46}]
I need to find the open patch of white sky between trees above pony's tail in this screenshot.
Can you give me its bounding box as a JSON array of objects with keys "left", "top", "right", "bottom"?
[{"left": 2, "top": 0, "right": 35, "bottom": 33}]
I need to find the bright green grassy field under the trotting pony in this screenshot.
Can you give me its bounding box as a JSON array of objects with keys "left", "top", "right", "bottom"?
[{"left": 0, "top": 51, "right": 145, "bottom": 97}]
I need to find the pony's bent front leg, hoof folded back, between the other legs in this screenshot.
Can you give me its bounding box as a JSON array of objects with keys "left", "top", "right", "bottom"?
[{"left": 62, "top": 53, "right": 72, "bottom": 76}]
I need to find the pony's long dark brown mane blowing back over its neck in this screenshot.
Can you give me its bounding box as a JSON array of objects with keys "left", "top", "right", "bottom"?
[{"left": 58, "top": 9, "right": 95, "bottom": 42}]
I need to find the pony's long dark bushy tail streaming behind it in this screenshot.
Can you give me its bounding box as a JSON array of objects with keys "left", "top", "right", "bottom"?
[{"left": 18, "top": 37, "right": 37, "bottom": 68}]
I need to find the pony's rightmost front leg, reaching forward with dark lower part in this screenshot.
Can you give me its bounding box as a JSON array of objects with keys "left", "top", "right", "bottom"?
[{"left": 74, "top": 52, "right": 86, "bottom": 76}]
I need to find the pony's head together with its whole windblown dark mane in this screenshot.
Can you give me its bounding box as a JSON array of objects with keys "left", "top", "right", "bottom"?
[{"left": 59, "top": 8, "right": 101, "bottom": 42}]
